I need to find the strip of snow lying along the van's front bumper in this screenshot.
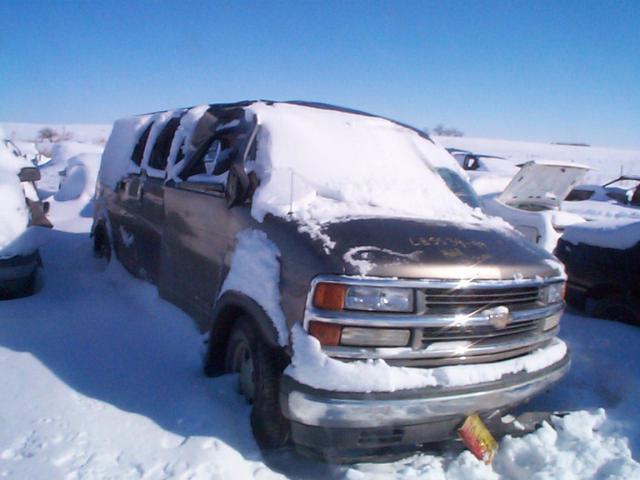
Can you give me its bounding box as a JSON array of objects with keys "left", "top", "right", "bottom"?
[{"left": 285, "top": 325, "right": 567, "bottom": 392}]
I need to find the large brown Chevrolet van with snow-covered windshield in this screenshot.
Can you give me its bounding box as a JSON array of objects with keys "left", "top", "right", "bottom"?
[{"left": 92, "top": 101, "right": 569, "bottom": 458}]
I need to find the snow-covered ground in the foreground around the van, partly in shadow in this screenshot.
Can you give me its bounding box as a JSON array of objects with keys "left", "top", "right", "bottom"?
[{"left": 0, "top": 132, "right": 640, "bottom": 479}]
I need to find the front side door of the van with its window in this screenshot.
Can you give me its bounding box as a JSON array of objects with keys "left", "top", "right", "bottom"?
[{"left": 160, "top": 107, "right": 254, "bottom": 329}]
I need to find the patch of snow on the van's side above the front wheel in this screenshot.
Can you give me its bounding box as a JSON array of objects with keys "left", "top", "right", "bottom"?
[{"left": 220, "top": 229, "right": 289, "bottom": 345}]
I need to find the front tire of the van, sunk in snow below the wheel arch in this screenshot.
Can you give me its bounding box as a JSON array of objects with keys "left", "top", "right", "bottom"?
[{"left": 225, "top": 315, "right": 290, "bottom": 449}]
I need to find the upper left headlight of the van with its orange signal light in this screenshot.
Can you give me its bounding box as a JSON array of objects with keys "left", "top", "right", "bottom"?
[{"left": 313, "top": 282, "right": 414, "bottom": 313}]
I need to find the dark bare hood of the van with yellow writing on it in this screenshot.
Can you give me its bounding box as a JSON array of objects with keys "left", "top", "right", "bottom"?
[{"left": 323, "top": 218, "right": 563, "bottom": 280}]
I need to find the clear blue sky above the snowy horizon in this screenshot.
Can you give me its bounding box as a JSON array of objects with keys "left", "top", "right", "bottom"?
[{"left": 0, "top": 0, "right": 640, "bottom": 147}]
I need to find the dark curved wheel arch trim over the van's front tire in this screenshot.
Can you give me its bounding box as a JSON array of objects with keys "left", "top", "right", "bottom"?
[{"left": 204, "top": 290, "right": 283, "bottom": 376}]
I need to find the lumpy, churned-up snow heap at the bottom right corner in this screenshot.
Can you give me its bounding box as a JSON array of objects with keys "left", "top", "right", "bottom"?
[{"left": 345, "top": 409, "right": 640, "bottom": 480}]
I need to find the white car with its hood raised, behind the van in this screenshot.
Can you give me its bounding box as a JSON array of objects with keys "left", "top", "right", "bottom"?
[{"left": 480, "top": 161, "right": 590, "bottom": 252}]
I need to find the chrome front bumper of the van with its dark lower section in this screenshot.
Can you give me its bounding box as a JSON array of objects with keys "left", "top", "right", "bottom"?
[{"left": 280, "top": 346, "right": 570, "bottom": 456}]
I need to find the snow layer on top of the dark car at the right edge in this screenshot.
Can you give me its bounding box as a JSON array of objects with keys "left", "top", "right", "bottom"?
[{"left": 562, "top": 219, "right": 640, "bottom": 250}]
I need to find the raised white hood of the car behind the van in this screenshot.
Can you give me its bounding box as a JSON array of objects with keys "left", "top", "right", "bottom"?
[{"left": 498, "top": 161, "right": 589, "bottom": 209}]
